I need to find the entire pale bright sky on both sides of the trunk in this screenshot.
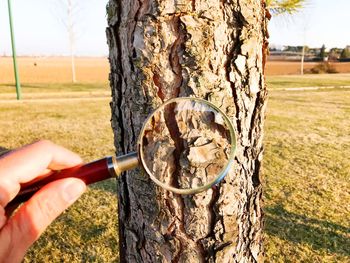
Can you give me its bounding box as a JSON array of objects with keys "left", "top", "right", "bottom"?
[{"left": 0, "top": 0, "right": 350, "bottom": 56}]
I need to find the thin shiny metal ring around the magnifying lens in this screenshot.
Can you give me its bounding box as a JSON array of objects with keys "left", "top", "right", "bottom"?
[{"left": 138, "top": 97, "right": 236, "bottom": 194}]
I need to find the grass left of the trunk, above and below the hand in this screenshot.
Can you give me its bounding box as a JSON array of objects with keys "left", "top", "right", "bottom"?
[{"left": 0, "top": 86, "right": 119, "bottom": 262}]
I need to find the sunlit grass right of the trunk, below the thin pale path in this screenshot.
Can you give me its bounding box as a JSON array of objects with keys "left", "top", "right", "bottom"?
[{"left": 263, "top": 89, "right": 350, "bottom": 262}]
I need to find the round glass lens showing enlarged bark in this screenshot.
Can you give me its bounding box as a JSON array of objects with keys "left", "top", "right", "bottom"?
[{"left": 140, "top": 98, "right": 234, "bottom": 193}]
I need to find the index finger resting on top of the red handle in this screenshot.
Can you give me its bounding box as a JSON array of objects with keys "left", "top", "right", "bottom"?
[{"left": 0, "top": 140, "right": 82, "bottom": 207}]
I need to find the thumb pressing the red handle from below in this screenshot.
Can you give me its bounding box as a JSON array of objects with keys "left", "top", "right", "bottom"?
[{"left": 0, "top": 178, "right": 86, "bottom": 259}]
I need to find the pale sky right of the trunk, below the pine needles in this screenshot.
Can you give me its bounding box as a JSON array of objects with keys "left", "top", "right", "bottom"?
[{"left": 269, "top": 0, "right": 350, "bottom": 48}]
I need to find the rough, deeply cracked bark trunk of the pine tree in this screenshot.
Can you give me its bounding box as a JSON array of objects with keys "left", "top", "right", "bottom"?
[{"left": 107, "top": 0, "right": 267, "bottom": 262}]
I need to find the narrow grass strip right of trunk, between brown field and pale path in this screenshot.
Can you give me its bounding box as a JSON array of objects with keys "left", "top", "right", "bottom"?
[{"left": 266, "top": 74, "right": 350, "bottom": 89}]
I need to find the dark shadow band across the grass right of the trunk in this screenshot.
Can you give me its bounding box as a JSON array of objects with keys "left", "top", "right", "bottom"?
[{"left": 265, "top": 205, "right": 350, "bottom": 256}]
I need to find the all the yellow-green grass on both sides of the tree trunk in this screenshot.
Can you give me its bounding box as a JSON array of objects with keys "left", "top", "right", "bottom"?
[{"left": 0, "top": 58, "right": 350, "bottom": 262}]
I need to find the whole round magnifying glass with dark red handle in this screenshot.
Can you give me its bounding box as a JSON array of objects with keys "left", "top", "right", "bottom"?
[{"left": 10, "top": 97, "right": 236, "bottom": 207}]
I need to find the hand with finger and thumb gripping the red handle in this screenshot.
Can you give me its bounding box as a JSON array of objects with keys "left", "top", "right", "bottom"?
[{"left": 0, "top": 140, "right": 86, "bottom": 262}]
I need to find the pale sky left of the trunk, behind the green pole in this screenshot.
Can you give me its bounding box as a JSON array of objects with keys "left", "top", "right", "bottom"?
[{"left": 0, "top": 0, "right": 108, "bottom": 56}]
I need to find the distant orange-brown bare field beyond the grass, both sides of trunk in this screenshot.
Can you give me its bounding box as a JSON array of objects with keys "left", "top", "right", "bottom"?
[{"left": 0, "top": 57, "right": 350, "bottom": 84}]
